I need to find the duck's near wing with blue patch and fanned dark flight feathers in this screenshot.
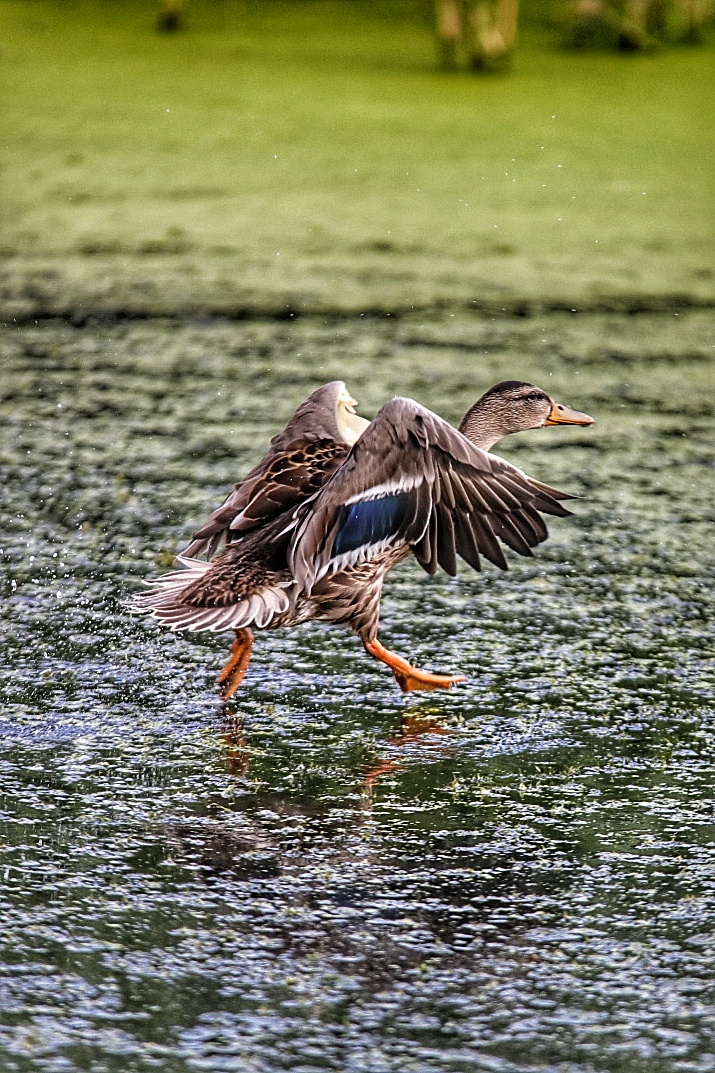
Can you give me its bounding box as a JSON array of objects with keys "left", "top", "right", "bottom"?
[{"left": 289, "top": 398, "right": 572, "bottom": 592}]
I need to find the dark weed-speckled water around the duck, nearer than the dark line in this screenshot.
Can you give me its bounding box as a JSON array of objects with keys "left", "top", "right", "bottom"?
[{"left": 0, "top": 312, "right": 715, "bottom": 1073}]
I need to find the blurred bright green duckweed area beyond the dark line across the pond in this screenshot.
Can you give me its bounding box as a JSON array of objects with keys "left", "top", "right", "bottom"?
[{"left": 0, "top": 0, "right": 713, "bottom": 319}]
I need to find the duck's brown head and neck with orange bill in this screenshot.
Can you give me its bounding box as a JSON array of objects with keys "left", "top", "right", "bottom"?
[{"left": 459, "top": 380, "right": 594, "bottom": 451}]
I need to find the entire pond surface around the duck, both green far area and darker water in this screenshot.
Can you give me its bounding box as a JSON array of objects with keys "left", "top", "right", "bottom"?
[{"left": 0, "top": 6, "right": 715, "bottom": 1073}]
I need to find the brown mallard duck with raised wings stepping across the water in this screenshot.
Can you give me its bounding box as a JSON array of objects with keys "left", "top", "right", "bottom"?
[{"left": 132, "top": 380, "right": 594, "bottom": 699}]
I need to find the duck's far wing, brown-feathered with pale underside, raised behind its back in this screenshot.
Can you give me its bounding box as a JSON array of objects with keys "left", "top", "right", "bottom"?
[{"left": 181, "top": 380, "right": 350, "bottom": 558}]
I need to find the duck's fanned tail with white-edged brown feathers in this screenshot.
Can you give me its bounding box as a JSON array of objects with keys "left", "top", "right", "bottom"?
[{"left": 128, "top": 556, "right": 293, "bottom": 633}]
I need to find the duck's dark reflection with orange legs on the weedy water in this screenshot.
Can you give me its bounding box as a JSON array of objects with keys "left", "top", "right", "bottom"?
[{"left": 166, "top": 704, "right": 571, "bottom": 974}]
